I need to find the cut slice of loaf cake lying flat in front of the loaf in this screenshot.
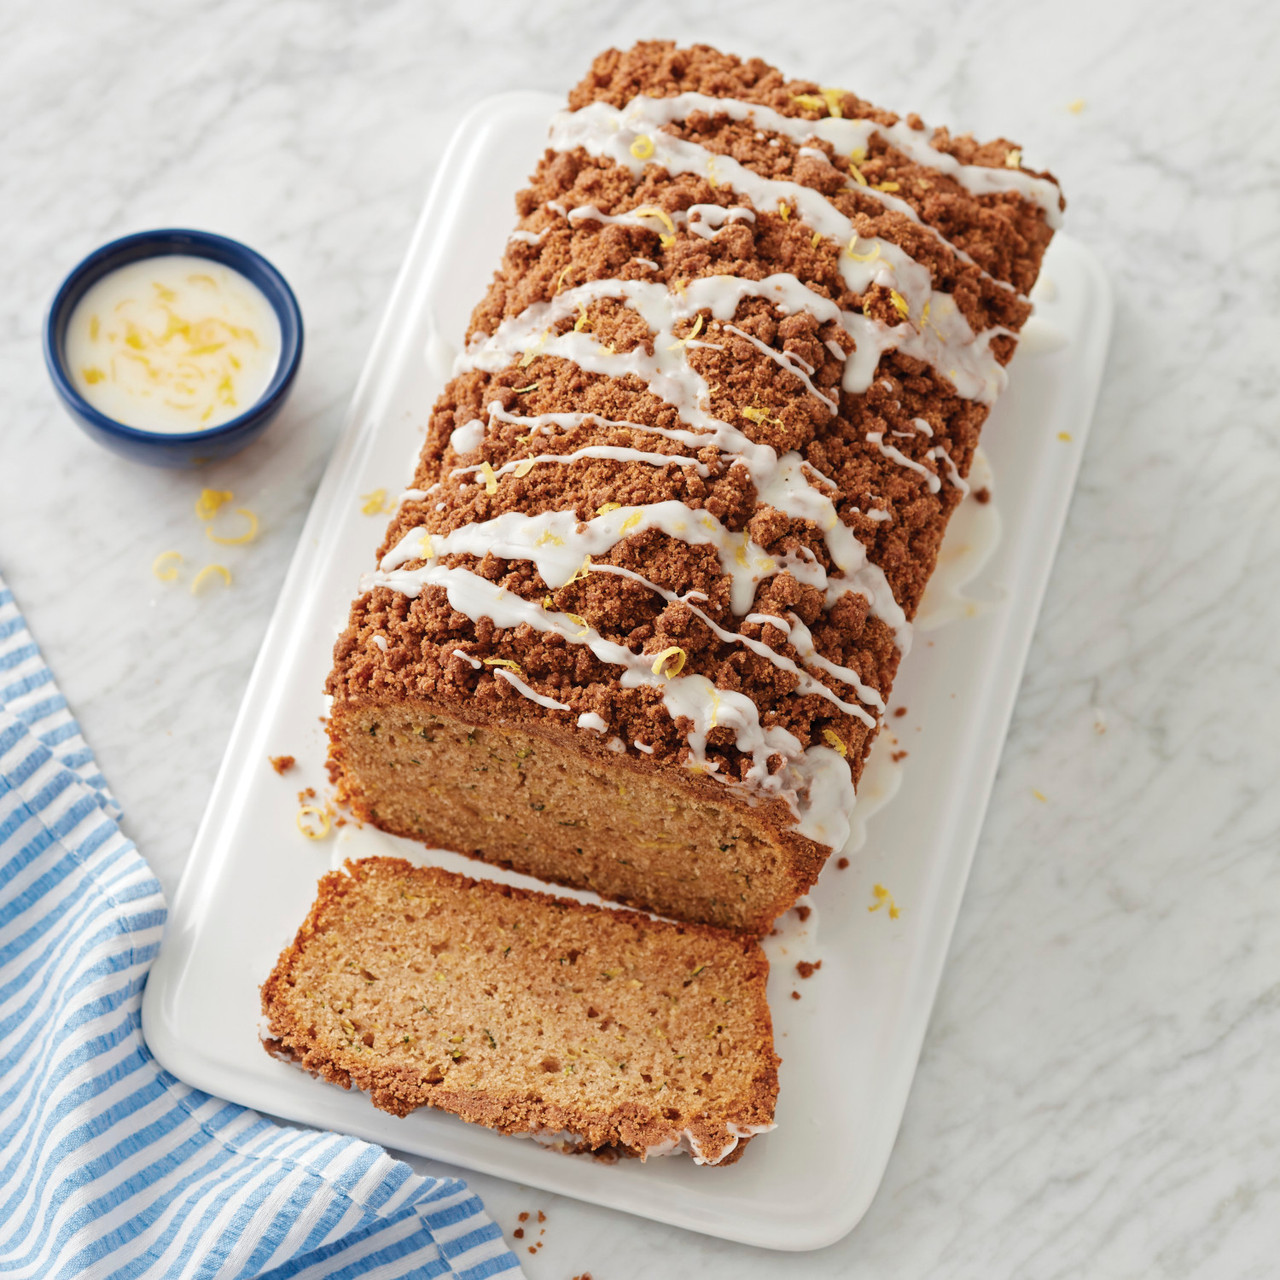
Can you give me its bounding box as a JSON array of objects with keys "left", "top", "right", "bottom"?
[{"left": 262, "top": 858, "right": 778, "bottom": 1165}]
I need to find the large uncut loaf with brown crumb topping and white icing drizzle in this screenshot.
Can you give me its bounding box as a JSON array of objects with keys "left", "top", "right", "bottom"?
[{"left": 328, "top": 42, "right": 1064, "bottom": 934}]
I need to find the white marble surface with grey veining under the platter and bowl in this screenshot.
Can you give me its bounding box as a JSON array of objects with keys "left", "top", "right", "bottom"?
[{"left": 0, "top": 0, "right": 1280, "bottom": 1280}]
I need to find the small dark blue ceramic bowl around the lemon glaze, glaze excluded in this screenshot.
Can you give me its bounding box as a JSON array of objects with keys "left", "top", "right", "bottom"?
[{"left": 45, "top": 230, "right": 302, "bottom": 467}]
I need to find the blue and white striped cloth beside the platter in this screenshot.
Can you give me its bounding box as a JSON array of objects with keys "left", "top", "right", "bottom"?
[{"left": 0, "top": 577, "right": 520, "bottom": 1280}]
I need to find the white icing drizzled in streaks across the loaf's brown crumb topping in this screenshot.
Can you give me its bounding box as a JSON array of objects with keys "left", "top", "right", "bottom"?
[{"left": 372, "top": 85, "right": 1029, "bottom": 839}]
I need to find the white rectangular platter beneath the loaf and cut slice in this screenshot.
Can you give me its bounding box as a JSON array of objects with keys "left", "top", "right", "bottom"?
[{"left": 143, "top": 93, "right": 1111, "bottom": 1249}]
